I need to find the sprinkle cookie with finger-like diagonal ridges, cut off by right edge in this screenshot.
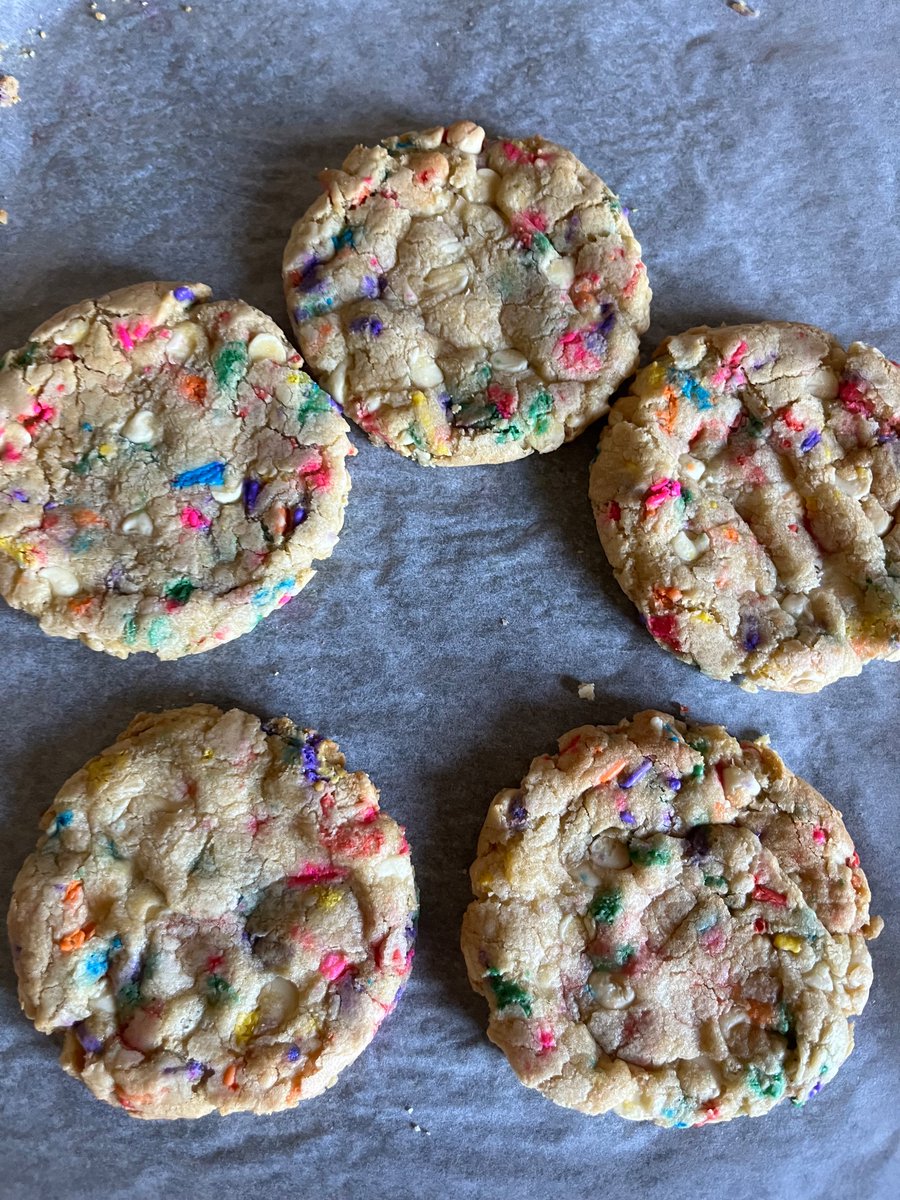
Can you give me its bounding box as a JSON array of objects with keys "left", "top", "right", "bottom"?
[{"left": 590, "top": 323, "right": 900, "bottom": 692}]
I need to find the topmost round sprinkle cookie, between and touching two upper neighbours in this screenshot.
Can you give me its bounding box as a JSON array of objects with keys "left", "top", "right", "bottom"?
[{"left": 284, "top": 121, "right": 650, "bottom": 466}]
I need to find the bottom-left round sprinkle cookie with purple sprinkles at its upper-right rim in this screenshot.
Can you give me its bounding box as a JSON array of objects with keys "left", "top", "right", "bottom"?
[{"left": 10, "top": 704, "right": 416, "bottom": 1118}]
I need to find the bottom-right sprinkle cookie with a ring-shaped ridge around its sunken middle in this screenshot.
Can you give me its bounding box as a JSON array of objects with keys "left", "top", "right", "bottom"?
[{"left": 462, "top": 712, "right": 882, "bottom": 1128}]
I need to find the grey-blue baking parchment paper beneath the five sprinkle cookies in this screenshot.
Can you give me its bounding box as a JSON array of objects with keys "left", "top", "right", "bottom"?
[{"left": 0, "top": 0, "right": 900, "bottom": 1200}]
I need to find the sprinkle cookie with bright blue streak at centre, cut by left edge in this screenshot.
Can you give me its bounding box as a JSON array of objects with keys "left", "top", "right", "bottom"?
[{"left": 0, "top": 283, "right": 355, "bottom": 659}]
